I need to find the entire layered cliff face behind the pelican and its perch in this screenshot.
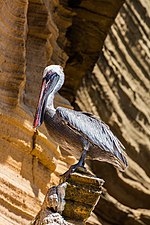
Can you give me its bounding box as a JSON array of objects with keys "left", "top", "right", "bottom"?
[{"left": 0, "top": 0, "right": 150, "bottom": 225}]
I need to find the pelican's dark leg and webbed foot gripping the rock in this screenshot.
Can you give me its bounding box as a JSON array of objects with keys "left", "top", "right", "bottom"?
[{"left": 61, "top": 141, "right": 89, "bottom": 180}]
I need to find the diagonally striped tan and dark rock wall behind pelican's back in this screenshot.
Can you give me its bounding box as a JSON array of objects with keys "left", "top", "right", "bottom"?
[{"left": 76, "top": 1, "right": 150, "bottom": 225}]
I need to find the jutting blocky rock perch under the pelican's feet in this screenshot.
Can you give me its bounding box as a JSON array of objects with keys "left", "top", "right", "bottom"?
[{"left": 31, "top": 171, "right": 104, "bottom": 225}]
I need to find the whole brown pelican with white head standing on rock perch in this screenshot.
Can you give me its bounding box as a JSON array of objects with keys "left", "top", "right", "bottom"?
[{"left": 33, "top": 65, "right": 127, "bottom": 178}]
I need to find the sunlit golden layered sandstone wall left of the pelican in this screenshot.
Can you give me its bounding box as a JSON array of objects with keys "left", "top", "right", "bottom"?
[{"left": 0, "top": 0, "right": 74, "bottom": 225}]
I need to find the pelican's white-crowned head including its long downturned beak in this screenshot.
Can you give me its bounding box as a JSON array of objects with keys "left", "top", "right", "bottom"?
[{"left": 33, "top": 65, "right": 64, "bottom": 128}]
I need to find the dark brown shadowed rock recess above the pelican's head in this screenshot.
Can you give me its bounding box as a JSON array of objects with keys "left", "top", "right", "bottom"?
[{"left": 60, "top": 0, "right": 124, "bottom": 102}]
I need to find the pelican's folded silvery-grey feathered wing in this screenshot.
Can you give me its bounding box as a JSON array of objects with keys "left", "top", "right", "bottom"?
[{"left": 56, "top": 107, "right": 127, "bottom": 168}]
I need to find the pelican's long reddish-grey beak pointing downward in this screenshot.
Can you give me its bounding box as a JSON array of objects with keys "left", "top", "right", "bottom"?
[{"left": 33, "top": 79, "right": 46, "bottom": 128}]
